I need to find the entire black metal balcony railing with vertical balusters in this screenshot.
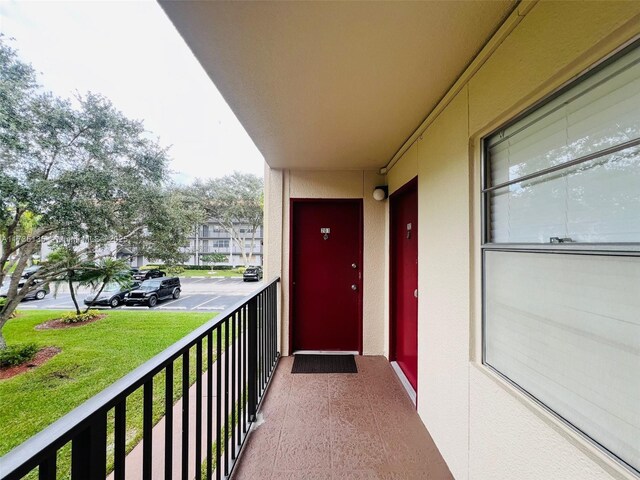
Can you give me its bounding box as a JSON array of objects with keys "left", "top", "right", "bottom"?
[{"left": 0, "top": 278, "right": 280, "bottom": 480}]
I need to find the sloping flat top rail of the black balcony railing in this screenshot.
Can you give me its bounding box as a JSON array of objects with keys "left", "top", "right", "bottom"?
[{"left": 0, "top": 277, "right": 280, "bottom": 478}]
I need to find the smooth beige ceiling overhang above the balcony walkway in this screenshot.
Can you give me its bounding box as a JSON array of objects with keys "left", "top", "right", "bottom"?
[{"left": 161, "top": 0, "right": 515, "bottom": 170}]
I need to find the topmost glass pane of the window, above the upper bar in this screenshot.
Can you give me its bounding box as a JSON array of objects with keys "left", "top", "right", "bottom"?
[{"left": 487, "top": 49, "right": 640, "bottom": 185}]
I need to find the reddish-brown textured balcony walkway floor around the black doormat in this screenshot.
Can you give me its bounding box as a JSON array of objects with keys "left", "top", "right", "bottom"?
[{"left": 232, "top": 357, "right": 453, "bottom": 480}]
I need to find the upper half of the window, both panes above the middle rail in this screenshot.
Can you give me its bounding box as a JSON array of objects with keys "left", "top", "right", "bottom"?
[{"left": 485, "top": 49, "right": 640, "bottom": 243}]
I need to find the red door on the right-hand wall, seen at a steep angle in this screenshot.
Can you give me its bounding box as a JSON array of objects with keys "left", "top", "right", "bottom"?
[{"left": 390, "top": 179, "right": 418, "bottom": 392}]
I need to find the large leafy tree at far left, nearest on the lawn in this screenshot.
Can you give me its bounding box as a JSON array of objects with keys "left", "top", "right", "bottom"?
[{"left": 0, "top": 36, "right": 199, "bottom": 348}]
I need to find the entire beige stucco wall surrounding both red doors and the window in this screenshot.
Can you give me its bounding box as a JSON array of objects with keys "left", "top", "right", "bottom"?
[{"left": 266, "top": 1, "right": 640, "bottom": 480}]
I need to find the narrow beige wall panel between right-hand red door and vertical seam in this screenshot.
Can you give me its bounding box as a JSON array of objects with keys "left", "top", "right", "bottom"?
[{"left": 418, "top": 89, "right": 470, "bottom": 478}]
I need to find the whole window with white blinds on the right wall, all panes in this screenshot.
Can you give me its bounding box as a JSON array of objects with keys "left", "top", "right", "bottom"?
[{"left": 482, "top": 44, "right": 640, "bottom": 473}]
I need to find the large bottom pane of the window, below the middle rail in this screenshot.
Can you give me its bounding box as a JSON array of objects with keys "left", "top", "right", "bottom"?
[{"left": 484, "top": 251, "right": 640, "bottom": 469}]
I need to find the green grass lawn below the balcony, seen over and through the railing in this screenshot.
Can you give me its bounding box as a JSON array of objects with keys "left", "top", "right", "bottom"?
[{"left": 0, "top": 310, "right": 218, "bottom": 478}]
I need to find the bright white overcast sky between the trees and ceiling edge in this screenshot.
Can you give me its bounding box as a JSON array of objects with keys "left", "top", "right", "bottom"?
[{"left": 0, "top": 0, "right": 263, "bottom": 182}]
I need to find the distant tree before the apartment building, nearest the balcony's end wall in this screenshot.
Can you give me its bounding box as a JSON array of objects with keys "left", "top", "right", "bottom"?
[{"left": 193, "top": 172, "right": 264, "bottom": 266}]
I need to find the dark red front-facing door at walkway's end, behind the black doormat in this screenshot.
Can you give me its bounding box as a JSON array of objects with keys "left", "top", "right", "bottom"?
[{"left": 290, "top": 200, "right": 362, "bottom": 352}]
